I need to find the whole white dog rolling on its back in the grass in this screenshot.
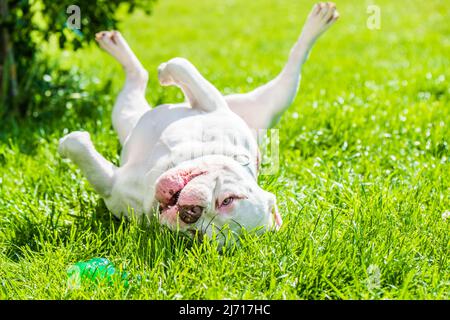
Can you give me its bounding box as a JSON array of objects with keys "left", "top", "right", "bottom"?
[{"left": 58, "top": 2, "right": 338, "bottom": 240}]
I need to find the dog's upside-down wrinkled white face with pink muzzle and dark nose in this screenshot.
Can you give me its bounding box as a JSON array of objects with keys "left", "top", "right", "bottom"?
[{"left": 155, "top": 156, "right": 282, "bottom": 240}]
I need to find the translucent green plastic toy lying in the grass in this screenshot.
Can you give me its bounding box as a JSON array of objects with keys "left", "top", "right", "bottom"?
[{"left": 67, "top": 258, "right": 129, "bottom": 289}]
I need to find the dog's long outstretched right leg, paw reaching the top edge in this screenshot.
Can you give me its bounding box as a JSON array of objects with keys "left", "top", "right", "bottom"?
[{"left": 225, "top": 2, "right": 339, "bottom": 129}]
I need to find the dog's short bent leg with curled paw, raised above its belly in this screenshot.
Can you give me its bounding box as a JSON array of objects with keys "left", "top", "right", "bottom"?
[{"left": 158, "top": 58, "right": 227, "bottom": 111}]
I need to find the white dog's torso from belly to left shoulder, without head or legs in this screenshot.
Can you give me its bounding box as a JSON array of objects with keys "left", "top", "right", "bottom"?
[{"left": 106, "top": 104, "right": 258, "bottom": 218}]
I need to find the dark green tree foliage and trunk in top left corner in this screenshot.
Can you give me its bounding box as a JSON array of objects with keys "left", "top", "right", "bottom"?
[{"left": 0, "top": 0, "right": 155, "bottom": 115}]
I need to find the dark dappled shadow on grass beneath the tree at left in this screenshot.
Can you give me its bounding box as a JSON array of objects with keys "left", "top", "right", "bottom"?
[{"left": 0, "top": 62, "right": 112, "bottom": 161}]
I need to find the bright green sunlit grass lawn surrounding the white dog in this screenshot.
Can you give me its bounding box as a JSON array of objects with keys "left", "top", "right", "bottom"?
[{"left": 0, "top": 0, "right": 450, "bottom": 299}]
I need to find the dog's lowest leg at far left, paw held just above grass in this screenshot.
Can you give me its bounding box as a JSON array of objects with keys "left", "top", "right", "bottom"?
[{"left": 58, "top": 131, "right": 116, "bottom": 197}]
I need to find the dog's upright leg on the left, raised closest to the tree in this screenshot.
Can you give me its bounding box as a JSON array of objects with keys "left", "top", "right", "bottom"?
[{"left": 95, "top": 31, "right": 150, "bottom": 144}]
